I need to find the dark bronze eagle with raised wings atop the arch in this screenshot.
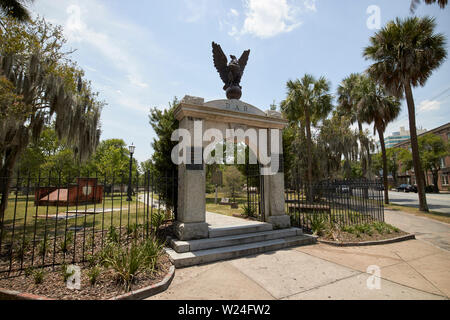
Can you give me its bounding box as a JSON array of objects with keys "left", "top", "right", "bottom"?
[{"left": 212, "top": 42, "right": 250, "bottom": 100}]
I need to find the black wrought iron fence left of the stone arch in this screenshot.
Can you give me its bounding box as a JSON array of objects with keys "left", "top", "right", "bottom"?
[{"left": 0, "top": 172, "right": 178, "bottom": 276}]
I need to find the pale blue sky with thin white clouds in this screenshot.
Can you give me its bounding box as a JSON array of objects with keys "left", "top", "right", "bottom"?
[{"left": 31, "top": 0, "right": 450, "bottom": 161}]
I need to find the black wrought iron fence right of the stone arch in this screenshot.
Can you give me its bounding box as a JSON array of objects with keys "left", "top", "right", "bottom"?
[{"left": 285, "top": 179, "right": 384, "bottom": 232}]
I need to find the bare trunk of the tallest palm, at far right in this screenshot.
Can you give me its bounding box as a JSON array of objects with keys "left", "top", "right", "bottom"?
[{"left": 405, "top": 81, "right": 429, "bottom": 212}]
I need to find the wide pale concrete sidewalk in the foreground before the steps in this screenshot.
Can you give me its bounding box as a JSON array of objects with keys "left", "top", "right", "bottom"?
[{"left": 151, "top": 240, "right": 450, "bottom": 300}]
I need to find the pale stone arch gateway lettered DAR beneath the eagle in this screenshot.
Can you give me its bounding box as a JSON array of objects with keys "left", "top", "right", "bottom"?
[{"left": 175, "top": 96, "right": 290, "bottom": 240}]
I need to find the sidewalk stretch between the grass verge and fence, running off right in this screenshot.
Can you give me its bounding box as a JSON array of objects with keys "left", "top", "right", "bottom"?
[{"left": 385, "top": 209, "right": 450, "bottom": 251}]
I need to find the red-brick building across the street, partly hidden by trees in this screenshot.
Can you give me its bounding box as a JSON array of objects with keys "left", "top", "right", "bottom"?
[{"left": 394, "top": 122, "right": 450, "bottom": 191}]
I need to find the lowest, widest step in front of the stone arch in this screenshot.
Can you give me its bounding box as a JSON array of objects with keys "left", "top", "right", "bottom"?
[{"left": 166, "top": 235, "right": 316, "bottom": 268}]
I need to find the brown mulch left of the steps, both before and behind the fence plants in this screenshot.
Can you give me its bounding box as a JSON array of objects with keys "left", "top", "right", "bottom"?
[{"left": 0, "top": 222, "right": 173, "bottom": 300}]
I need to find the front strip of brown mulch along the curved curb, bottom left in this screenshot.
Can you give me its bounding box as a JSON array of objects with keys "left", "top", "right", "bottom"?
[{"left": 0, "top": 255, "right": 172, "bottom": 300}]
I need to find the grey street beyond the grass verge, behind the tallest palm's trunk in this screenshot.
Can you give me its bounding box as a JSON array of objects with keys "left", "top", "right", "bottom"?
[{"left": 389, "top": 191, "right": 450, "bottom": 214}]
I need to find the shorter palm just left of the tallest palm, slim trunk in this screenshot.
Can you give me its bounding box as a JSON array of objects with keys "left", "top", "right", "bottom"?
[{"left": 356, "top": 76, "right": 401, "bottom": 204}]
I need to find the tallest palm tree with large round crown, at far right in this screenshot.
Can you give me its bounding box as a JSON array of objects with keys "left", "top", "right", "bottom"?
[{"left": 364, "top": 17, "right": 447, "bottom": 212}]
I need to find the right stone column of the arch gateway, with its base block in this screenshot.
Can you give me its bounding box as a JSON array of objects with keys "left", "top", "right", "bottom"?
[{"left": 268, "top": 130, "right": 291, "bottom": 229}]
